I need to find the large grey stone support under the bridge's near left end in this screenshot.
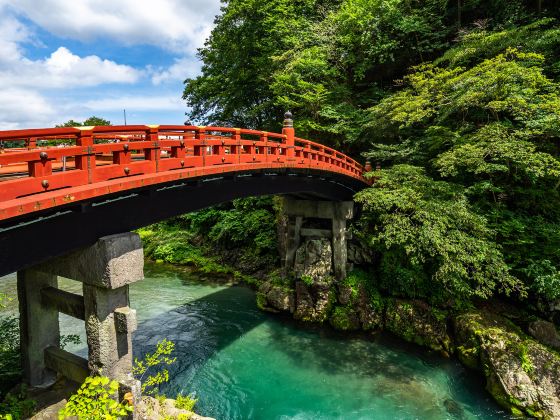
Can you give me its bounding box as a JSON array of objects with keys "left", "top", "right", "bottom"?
[{"left": 18, "top": 233, "right": 144, "bottom": 398}]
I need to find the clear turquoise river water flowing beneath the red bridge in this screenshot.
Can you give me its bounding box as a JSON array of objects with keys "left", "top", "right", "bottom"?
[{"left": 0, "top": 264, "right": 507, "bottom": 420}]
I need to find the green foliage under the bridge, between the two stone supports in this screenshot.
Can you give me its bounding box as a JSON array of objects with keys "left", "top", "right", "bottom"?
[{"left": 139, "top": 197, "right": 278, "bottom": 282}]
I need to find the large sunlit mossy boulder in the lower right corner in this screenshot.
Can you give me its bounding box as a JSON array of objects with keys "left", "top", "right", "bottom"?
[{"left": 454, "top": 310, "right": 560, "bottom": 419}]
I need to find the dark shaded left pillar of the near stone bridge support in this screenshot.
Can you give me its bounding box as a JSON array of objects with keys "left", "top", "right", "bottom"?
[{"left": 17, "top": 269, "right": 60, "bottom": 386}]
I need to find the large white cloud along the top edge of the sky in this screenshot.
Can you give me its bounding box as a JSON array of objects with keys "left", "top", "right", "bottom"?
[{"left": 9, "top": 0, "right": 220, "bottom": 53}]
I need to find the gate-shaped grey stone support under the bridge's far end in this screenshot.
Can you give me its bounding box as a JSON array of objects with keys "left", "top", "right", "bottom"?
[{"left": 280, "top": 197, "right": 354, "bottom": 280}]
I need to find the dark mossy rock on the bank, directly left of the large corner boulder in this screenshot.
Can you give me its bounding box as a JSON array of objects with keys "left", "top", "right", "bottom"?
[{"left": 385, "top": 299, "right": 452, "bottom": 353}]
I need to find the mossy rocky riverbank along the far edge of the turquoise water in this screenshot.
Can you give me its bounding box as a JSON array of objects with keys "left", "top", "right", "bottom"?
[{"left": 139, "top": 226, "right": 560, "bottom": 419}]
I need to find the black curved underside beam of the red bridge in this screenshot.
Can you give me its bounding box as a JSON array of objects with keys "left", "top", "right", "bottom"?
[{"left": 0, "top": 169, "right": 366, "bottom": 276}]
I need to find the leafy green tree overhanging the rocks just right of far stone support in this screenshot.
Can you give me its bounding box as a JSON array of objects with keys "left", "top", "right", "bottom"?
[{"left": 356, "top": 165, "right": 522, "bottom": 300}]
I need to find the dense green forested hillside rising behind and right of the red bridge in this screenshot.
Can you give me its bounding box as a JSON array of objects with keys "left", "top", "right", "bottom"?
[{"left": 184, "top": 0, "right": 560, "bottom": 304}]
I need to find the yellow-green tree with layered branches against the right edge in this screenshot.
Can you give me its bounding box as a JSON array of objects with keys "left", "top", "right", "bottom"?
[{"left": 369, "top": 49, "right": 560, "bottom": 304}]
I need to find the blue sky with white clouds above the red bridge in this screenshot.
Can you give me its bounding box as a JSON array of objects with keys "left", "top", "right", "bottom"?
[{"left": 0, "top": 0, "right": 220, "bottom": 130}]
